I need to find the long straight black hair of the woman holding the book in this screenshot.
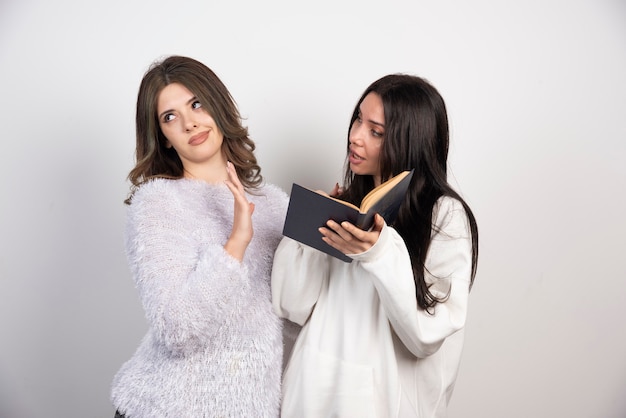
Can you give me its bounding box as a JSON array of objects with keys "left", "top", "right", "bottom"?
[{"left": 340, "top": 74, "right": 478, "bottom": 310}]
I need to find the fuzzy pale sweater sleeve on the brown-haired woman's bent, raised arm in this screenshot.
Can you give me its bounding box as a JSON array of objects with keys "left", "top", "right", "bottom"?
[{"left": 126, "top": 183, "right": 249, "bottom": 355}]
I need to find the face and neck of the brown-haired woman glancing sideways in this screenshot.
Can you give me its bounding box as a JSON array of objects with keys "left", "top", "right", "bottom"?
[{"left": 157, "top": 83, "right": 226, "bottom": 175}]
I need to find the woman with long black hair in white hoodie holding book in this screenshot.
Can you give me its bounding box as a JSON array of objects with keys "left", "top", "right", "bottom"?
[{"left": 272, "top": 74, "right": 478, "bottom": 418}]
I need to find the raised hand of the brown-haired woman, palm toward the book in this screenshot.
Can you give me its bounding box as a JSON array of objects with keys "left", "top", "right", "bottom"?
[{"left": 224, "top": 161, "right": 254, "bottom": 261}]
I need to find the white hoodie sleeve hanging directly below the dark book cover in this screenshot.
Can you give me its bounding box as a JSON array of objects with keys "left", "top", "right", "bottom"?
[{"left": 272, "top": 237, "right": 328, "bottom": 325}]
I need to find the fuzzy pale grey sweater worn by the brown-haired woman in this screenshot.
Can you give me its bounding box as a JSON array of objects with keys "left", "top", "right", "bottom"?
[{"left": 111, "top": 179, "right": 288, "bottom": 418}]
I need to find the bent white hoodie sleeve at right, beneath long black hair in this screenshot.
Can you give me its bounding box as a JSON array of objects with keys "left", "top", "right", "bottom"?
[{"left": 353, "top": 198, "right": 472, "bottom": 358}]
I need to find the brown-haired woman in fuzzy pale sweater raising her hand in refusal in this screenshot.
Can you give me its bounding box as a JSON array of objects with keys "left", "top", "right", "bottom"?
[{"left": 111, "top": 56, "right": 287, "bottom": 418}]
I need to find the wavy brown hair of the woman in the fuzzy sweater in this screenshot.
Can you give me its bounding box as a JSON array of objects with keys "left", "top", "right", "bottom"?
[{"left": 125, "top": 56, "right": 263, "bottom": 204}]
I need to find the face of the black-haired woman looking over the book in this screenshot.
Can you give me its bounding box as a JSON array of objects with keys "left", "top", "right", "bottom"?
[{"left": 348, "top": 92, "right": 385, "bottom": 186}]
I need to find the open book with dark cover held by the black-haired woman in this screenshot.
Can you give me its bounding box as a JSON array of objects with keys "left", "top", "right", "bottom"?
[{"left": 283, "top": 170, "right": 413, "bottom": 262}]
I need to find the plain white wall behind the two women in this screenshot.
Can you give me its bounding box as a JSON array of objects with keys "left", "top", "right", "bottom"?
[{"left": 0, "top": 0, "right": 626, "bottom": 418}]
